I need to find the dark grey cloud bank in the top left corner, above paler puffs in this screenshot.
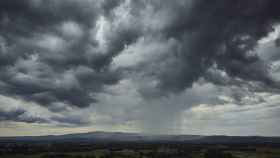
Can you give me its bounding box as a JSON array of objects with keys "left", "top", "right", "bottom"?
[{"left": 0, "top": 0, "right": 99, "bottom": 29}]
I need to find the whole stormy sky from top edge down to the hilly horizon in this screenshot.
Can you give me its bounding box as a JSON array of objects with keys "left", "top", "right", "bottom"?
[{"left": 0, "top": 0, "right": 280, "bottom": 136}]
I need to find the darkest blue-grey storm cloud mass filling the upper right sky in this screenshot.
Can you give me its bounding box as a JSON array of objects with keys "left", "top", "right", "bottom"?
[{"left": 147, "top": 0, "right": 280, "bottom": 94}]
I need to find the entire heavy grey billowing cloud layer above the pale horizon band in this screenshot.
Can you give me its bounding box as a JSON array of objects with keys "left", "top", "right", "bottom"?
[{"left": 0, "top": 0, "right": 280, "bottom": 131}]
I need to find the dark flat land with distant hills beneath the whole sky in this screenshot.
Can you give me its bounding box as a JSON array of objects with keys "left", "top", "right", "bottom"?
[{"left": 0, "top": 132, "right": 280, "bottom": 158}]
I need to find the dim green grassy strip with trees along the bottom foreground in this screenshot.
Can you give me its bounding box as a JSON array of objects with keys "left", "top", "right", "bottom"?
[{"left": 0, "top": 148, "right": 280, "bottom": 158}]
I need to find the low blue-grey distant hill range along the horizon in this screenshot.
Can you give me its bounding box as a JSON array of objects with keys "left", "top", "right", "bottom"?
[{"left": 0, "top": 132, "right": 280, "bottom": 144}]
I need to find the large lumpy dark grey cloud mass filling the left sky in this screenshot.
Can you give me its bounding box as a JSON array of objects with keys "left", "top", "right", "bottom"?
[{"left": 0, "top": 0, "right": 139, "bottom": 109}]
